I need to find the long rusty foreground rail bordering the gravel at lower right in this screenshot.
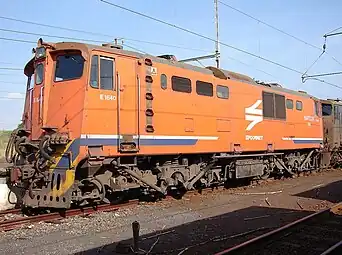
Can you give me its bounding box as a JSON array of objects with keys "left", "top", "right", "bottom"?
[{"left": 215, "top": 203, "right": 342, "bottom": 255}]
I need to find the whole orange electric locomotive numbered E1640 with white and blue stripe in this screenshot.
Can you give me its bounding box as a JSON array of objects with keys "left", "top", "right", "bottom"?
[{"left": 7, "top": 39, "right": 323, "bottom": 208}]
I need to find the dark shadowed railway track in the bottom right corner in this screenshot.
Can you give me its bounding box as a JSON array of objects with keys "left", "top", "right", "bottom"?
[{"left": 215, "top": 203, "right": 342, "bottom": 255}]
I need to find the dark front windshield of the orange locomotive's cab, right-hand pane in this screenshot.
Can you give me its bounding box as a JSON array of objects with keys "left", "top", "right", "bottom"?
[{"left": 54, "top": 54, "right": 84, "bottom": 82}]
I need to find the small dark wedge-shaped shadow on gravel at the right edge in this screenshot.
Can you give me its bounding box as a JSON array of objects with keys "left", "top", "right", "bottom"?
[{"left": 293, "top": 181, "right": 342, "bottom": 203}]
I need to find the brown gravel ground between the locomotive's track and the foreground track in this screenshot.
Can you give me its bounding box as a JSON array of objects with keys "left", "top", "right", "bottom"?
[{"left": 0, "top": 170, "right": 342, "bottom": 254}]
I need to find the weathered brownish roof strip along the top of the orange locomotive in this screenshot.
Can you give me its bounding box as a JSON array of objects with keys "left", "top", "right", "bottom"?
[{"left": 40, "top": 42, "right": 319, "bottom": 100}]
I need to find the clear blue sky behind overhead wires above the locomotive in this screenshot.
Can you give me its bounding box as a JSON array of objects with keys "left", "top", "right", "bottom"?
[{"left": 0, "top": 0, "right": 342, "bottom": 130}]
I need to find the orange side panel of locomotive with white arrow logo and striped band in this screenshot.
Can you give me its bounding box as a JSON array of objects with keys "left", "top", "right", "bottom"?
[{"left": 81, "top": 54, "right": 323, "bottom": 155}]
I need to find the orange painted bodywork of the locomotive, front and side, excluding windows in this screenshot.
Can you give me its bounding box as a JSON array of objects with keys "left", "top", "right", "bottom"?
[{"left": 24, "top": 43, "right": 323, "bottom": 163}]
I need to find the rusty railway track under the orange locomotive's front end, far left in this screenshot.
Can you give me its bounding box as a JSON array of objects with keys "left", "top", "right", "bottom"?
[{"left": 0, "top": 200, "right": 139, "bottom": 231}]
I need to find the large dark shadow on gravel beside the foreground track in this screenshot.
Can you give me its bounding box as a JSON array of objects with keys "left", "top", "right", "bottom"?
[{"left": 75, "top": 206, "right": 312, "bottom": 255}]
